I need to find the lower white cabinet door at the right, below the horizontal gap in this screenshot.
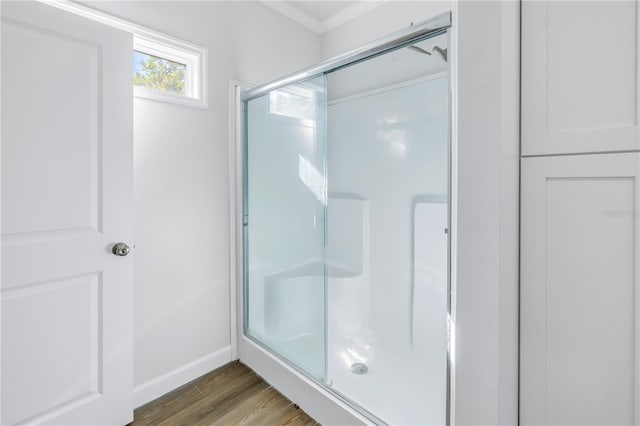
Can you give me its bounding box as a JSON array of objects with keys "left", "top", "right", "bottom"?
[{"left": 520, "top": 153, "right": 640, "bottom": 425}]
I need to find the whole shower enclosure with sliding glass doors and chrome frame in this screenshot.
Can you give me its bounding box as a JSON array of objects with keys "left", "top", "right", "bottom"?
[{"left": 242, "top": 14, "right": 451, "bottom": 424}]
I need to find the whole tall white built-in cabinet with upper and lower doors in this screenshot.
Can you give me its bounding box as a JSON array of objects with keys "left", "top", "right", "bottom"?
[{"left": 520, "top": 1, "right": 640, "bottom": 425}]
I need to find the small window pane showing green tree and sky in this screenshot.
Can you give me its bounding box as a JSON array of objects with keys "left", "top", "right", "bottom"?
[{"left": 133, "top": 52, "right": 187, "bottom": 96}]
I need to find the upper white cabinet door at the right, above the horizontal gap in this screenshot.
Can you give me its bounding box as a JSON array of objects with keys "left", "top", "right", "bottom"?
[{"left": 522, "top": 1, "right": 640, "bottom": 155}]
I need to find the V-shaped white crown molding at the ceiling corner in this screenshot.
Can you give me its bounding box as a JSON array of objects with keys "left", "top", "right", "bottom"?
[{"left": 262, "top": 0, "right": 390, "bottom": 34}]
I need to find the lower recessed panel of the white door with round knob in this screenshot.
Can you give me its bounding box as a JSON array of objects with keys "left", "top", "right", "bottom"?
[{"left": 2, "top": 273, "right": 102, "bottom": 423}]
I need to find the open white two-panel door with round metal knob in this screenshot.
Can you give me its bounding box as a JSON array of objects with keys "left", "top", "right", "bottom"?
[{"left": 1, "top": 2, "right": 133, "bottom": 425}]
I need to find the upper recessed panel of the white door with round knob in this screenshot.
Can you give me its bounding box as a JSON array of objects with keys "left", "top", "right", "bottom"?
[{"left": 2, "top": 20, "right": 100, "bottom": 236}]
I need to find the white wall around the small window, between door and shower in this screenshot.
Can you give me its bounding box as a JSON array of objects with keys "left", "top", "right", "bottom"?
[{"left": 79, "top": 1, "right": 320, "bottom": 404}]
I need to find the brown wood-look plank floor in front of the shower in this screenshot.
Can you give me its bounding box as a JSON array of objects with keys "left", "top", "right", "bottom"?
[{"left": 131, "top": 361, "right": 318, "bottom": 426}]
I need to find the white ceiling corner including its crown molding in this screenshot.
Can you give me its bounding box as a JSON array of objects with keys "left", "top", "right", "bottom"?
[{"left": 263, "top": 0, "right": 388, "bottom": 33}]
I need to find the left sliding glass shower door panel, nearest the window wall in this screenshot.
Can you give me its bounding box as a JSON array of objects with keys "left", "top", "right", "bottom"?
[{"left": 244, "top": 76, "right": 327, "bottom": 380}]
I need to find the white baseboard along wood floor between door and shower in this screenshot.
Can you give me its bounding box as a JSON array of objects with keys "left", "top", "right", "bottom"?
[{"left": 133, "top": 346, "right": 231, "bottom": 407}]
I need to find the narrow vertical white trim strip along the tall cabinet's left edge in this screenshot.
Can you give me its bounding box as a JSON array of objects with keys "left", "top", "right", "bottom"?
[{"left": 498, "top": 2, "right": 520, "bottom": 425}]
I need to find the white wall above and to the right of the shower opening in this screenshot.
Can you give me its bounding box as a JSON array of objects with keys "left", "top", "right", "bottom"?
[{"left": 322, "top": 1, "right": 519, "bottom": 425}]
